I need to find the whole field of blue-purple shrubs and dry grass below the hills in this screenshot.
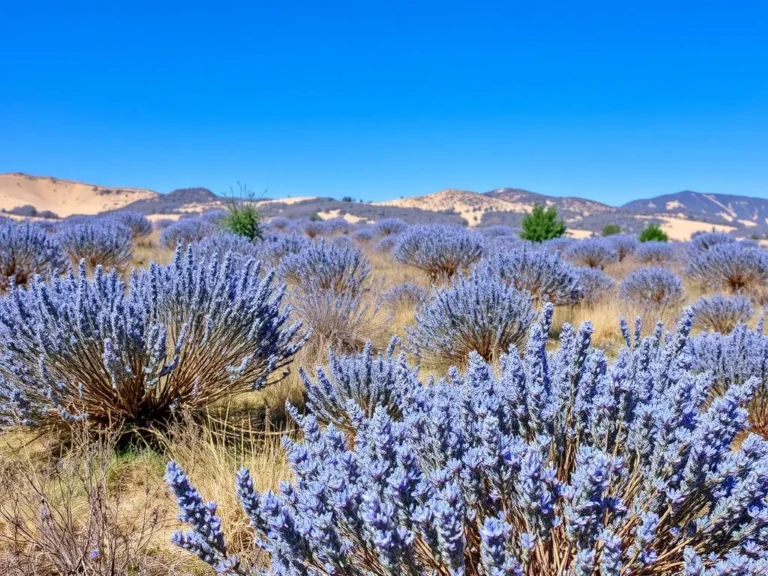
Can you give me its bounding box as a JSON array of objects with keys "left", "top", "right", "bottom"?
[{"left": 0, "top": 213, "right": 768, "bottom": 576}]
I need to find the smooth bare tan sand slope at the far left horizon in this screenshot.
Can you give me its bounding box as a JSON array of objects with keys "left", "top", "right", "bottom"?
[{"left": 0, "top": 173, "right": 157, "bottom": 217}]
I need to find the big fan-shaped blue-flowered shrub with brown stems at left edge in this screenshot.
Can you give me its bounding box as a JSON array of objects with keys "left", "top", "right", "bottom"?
[{"left": 0, "top": 250, "right": 302, "bottom": 428}]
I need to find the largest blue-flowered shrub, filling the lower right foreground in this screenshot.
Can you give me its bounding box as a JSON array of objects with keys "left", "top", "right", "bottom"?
[{"left": 166, "top": 308, "right": 768, "bottom": 576}]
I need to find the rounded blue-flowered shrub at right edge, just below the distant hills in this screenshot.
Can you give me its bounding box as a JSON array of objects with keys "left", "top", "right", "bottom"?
[{"left": 685, "top": 243, "right": 768, "bottom": 292}]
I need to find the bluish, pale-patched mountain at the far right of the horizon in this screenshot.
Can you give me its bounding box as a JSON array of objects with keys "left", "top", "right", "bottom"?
[{"left": 622, "top": 190, "right": 768, "bottom": 228}]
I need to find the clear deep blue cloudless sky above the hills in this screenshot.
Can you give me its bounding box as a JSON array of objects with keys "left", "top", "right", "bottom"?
[{"left": 0, "top": 0, "right": 768, "bottom": 204}]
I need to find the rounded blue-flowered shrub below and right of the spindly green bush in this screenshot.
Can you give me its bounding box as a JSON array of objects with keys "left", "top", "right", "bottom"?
[{"left": 279, "top": 240, "right": 371, "bottom": 292}]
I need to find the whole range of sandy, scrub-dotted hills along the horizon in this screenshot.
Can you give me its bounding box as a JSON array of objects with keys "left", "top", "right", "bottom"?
[{"left": 0, "top": 173, "right": 768, "bottom": 240}]
